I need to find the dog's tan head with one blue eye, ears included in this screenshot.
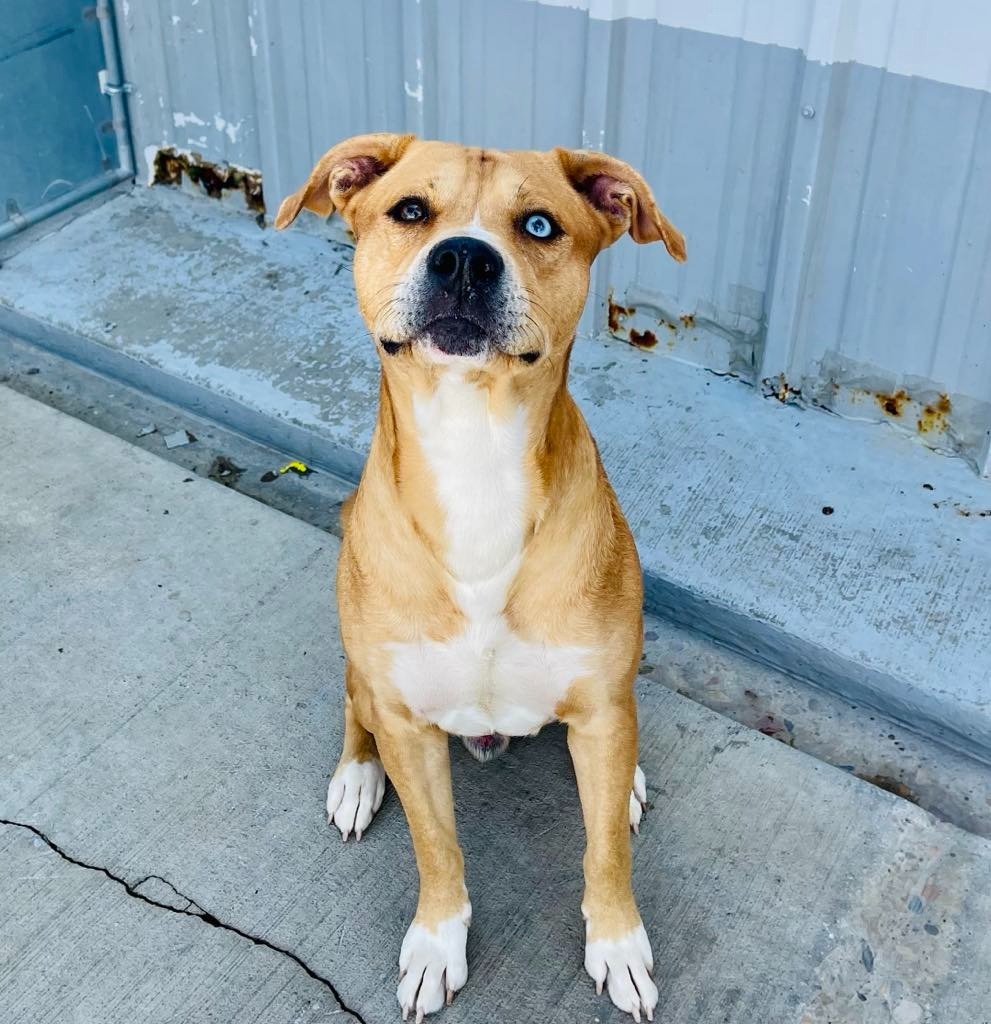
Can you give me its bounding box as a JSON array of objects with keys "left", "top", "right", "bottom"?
[{"left": 275, "top": 133, "right": 685, "bottom": 366}]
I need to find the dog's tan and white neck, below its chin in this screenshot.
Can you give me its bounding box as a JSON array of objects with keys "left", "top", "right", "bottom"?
[{"left": 375, "top": 356, "right": 576, "bottom": 584}]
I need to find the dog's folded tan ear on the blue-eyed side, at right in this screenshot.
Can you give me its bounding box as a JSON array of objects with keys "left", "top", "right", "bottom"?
[{"left": 554, "top": 148, "right": 686, "bottom": 263}]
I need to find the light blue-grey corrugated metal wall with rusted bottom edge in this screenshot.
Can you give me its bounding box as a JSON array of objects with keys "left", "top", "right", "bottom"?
[{"left": 110, "top": 0, "right": 991, "bottom": 472}]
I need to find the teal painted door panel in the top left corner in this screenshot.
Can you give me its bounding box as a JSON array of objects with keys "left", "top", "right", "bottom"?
[{"left": 0, "top": 0, "right": 120, "bottom": 233}]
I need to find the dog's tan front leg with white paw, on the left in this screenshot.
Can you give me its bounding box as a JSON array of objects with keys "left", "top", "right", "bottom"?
[{"left": 374, "top": 710, "right": 471, "bottom": 1021}]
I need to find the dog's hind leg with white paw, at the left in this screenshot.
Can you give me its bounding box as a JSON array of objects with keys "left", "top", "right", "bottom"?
[{"left": 327, "top": 666, "right": 385, "bottom": 843}]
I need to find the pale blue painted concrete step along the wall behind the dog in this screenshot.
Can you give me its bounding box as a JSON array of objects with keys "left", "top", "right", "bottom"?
[{"left": 0, "top": 189, "right": 991, "bottom": 761}]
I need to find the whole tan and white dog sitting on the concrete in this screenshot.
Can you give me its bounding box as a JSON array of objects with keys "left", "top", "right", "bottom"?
[{"left": 275, "top": 134, "right": 685, "bottom": 1021}]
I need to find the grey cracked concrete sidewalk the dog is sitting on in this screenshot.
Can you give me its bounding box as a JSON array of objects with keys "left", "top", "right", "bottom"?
[{"left": 0, "top": 388, "right": 991, "bottom": 1024}]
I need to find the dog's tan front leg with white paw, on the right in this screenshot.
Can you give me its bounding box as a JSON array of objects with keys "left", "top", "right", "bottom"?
[{"left": 565, "top": 691, "right": 657, "bottom": 1021}]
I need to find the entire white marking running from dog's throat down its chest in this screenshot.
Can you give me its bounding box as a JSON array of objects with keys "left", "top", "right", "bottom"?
[{"left": 384, "top": 367, "right": 590, "bottom": 736}]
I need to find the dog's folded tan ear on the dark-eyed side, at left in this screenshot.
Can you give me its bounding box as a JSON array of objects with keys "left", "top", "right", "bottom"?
[{"left": 275, "top": 132, "right": 416, "bottom": 230}]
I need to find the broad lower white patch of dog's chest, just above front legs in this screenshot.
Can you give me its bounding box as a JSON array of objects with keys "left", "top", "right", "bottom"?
[{"left": 390, "top": 615, "right": 591, "bottom": 736}]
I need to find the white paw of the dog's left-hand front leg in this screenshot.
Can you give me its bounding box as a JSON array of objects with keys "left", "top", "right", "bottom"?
[{"left": 396, "top": 903, "right": 471, "bottom": 1024}]
